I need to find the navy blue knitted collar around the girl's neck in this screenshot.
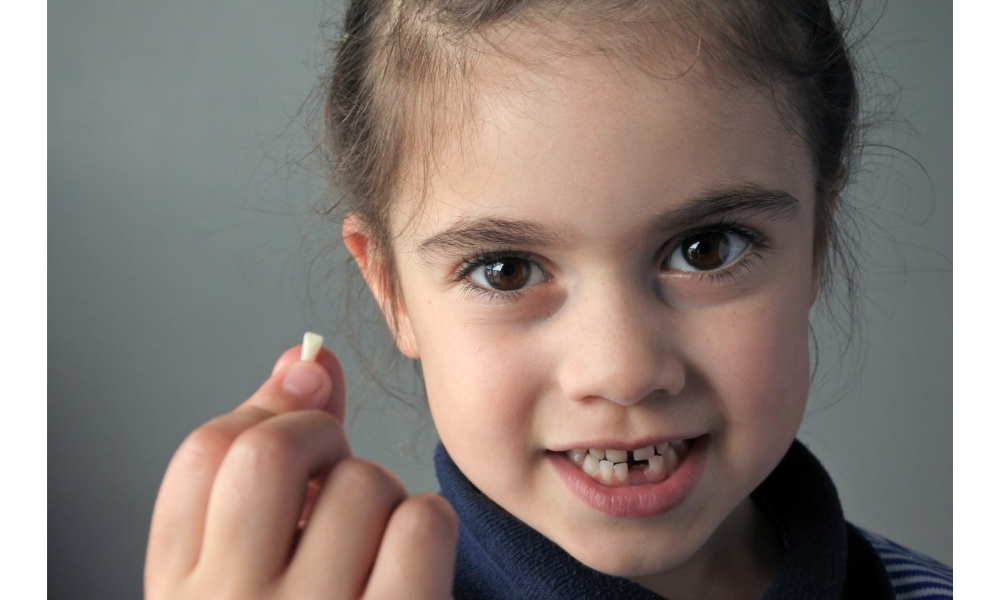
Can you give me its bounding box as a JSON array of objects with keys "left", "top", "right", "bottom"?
[{"left": 434, "top": 441, "right": 894, "bottom": 600}]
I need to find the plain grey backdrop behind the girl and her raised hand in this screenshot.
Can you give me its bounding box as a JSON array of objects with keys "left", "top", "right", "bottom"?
[{"left": 48, "top": 0, "right": 952, "bottom": 599}]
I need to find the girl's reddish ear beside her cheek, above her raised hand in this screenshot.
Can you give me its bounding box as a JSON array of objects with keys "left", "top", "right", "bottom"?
[{"left": 341, "top": 213, "right": 420, "bottom": 360}]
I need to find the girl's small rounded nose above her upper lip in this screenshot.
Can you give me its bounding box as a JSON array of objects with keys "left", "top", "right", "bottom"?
[{"left": 557, "top": 286, "right": 685, "bottom": 406}]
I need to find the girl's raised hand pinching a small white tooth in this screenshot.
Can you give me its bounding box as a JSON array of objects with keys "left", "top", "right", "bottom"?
[{"left": 145, "top": 347, "right": 458, "bottom": 600}]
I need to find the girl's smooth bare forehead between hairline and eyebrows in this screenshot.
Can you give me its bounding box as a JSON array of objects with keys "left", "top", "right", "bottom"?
[{"left": 395, "top": 51, "right": 813, "bottom": 244}]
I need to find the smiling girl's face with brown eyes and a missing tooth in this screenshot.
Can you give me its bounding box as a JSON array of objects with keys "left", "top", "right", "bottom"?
[{"left": 368, "top": 56, "right": 817, "bottom": 579}]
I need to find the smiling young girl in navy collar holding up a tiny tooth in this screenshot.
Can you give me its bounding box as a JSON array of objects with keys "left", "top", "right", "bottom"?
[{"left": 146, "top": 0, "right": 951, "bottom": 600}]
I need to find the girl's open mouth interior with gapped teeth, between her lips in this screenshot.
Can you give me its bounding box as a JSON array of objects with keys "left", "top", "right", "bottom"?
[{"left": 566, "top": 440, "right": 694, "bottom": 487}]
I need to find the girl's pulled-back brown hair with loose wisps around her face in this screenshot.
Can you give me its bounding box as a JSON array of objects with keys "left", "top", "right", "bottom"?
[{"left": 323, "top": 0, "right": 860, "bottom": 376}]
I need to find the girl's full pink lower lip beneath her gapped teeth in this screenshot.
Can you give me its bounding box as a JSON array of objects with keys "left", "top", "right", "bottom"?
[{"left": 549, "top": 435, "right": 708, "bottom": 519}]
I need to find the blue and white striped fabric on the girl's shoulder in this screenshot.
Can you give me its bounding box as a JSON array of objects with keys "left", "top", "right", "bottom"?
[{"left": 858, "top": 527, "right": 952, "bottom": 600}]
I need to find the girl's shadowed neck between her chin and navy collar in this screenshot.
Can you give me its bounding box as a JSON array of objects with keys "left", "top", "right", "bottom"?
[{"left": 633, "top": 498, "right": 781, "bottom": 600}]
